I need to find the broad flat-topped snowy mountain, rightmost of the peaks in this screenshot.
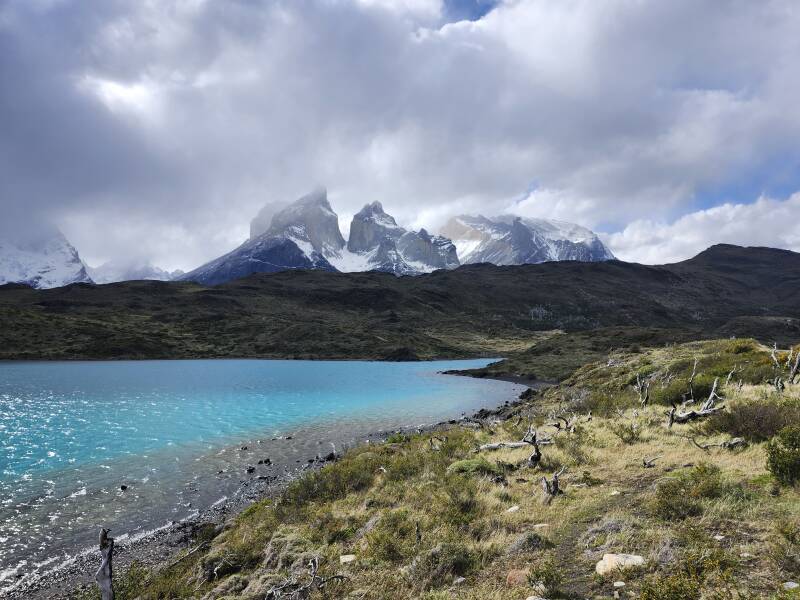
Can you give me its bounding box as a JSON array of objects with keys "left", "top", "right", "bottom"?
[{"left": 442, "top": 215, "right": 614, "bottom": 265}]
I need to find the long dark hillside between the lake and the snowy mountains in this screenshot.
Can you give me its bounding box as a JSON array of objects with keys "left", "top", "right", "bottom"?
[{"left": 0, "top": 246, "right": 800, "bottom": 359}]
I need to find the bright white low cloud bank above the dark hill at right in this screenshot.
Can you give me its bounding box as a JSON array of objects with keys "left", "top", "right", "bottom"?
[{"left": 605, "top": 193, "right": 800, "bottom": 264}]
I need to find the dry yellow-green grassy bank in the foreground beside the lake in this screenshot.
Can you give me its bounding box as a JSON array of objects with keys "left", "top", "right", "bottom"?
[{"left": 70, "top": 340, "right": 800, "bottom": 600}]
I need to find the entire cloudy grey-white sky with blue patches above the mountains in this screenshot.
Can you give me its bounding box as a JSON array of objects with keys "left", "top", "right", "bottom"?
[{"left": 0, "top": 0, "right": 800, "bottom": 270}]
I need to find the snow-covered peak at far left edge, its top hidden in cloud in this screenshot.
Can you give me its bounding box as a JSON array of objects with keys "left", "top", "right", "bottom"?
[{"left": 0, "top": 229, "right": 92, "bottom": 289}]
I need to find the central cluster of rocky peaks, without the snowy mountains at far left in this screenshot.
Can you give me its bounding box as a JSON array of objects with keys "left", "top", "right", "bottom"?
[{"left": 180, "top": 189, "right": 614, "bottom": 285}]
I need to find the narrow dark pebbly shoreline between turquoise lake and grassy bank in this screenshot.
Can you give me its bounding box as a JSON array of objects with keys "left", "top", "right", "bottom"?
[{"left": 0, "top": 370, "right": 536, "bottom": 600}]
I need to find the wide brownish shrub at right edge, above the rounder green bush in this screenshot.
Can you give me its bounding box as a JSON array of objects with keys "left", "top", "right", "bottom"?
[{"left": 703, "top": 401, "right": 800, "bottom": 442}]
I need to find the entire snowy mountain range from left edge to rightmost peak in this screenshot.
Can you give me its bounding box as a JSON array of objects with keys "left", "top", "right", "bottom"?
[{"left": 0, "top": 189, "right": 614, "bottom": 288}]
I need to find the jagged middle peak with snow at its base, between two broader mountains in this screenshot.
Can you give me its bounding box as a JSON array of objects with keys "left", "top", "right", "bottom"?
[{"left": 331, "top": 202, "right": 459, "bottom": 275}]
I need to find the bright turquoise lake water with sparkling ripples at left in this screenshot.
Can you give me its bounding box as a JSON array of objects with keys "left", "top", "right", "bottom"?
[{"left": 0, "top": 360, "right": 522, "bottom": 590}]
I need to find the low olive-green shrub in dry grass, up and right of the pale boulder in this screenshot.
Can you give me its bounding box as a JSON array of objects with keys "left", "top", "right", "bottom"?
[{"left": 653, "top": 463, "right": 725, "bottom": 520}]
